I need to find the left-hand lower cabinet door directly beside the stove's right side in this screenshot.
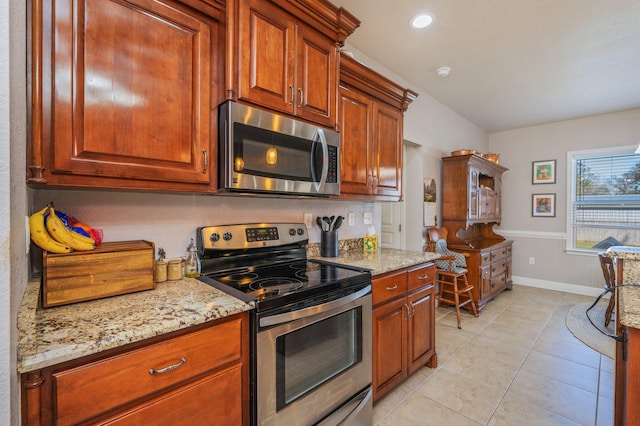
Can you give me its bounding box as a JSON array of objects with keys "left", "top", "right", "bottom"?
[{"left": 372, "top": 297, "right": 407, "bottom": 399}]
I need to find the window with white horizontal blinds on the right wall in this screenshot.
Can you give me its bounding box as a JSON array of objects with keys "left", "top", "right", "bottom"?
[{"left": 567, "top": 147, "right": 640, "bottom": 251}]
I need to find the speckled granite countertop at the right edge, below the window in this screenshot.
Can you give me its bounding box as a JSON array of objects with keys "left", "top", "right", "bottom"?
[{"left": 607, "top": 246, "right": 640, "bottom": 328}]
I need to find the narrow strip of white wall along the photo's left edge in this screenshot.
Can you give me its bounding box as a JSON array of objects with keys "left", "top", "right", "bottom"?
[{"left": 5, "top": 0, "right": 28, "bottom": 425}]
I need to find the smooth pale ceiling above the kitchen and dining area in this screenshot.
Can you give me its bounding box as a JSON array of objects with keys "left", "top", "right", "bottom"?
[{"left": 332, "top": 0, "right": 640, "bottom": 132}]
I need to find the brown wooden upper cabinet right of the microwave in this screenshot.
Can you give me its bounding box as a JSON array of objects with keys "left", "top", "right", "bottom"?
[{"left": 338, "top": 54, "right": 418, "bottom": 201}]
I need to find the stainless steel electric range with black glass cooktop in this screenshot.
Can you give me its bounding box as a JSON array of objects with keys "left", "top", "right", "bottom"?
[{"left": 197, "top": 223, "right": 372, "bottom": 426}]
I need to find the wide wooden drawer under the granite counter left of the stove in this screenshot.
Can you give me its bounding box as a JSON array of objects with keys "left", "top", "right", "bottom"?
[{"left": 53, "top": 319, "right": 242, "bottom": 425}]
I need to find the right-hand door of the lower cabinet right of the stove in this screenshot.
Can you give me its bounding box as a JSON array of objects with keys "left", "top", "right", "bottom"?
[{"left": 407, "top": 285, "right": 436, "bottom": 374}]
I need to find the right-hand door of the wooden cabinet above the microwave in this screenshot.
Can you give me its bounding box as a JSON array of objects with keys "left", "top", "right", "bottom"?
[{"left": 295, "top": 25, "right": 338, "bottom": 127}]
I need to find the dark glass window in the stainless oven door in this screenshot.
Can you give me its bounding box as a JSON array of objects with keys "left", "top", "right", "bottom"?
[{"left": 276, "top": 307, "right": 362, "bottom": 410}]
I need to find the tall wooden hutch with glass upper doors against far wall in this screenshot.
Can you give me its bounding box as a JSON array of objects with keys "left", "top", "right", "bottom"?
[{"left": 442, "top": 154, "right": 513, "bottom": 311}]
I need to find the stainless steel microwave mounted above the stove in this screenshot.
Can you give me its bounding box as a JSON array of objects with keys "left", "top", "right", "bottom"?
[{"left": 218, "top": 101, "right": 340, "bottom": 196}]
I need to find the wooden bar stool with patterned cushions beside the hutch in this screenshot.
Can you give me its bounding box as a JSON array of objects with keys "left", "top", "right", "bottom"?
[{"left": 427, "top": 228, "right": 478, "bottom": 329}]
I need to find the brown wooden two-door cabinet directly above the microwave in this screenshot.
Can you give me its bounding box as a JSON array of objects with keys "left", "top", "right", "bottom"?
[{"left": 226, "top": 0, "right": 360, "bottom": 128}]
